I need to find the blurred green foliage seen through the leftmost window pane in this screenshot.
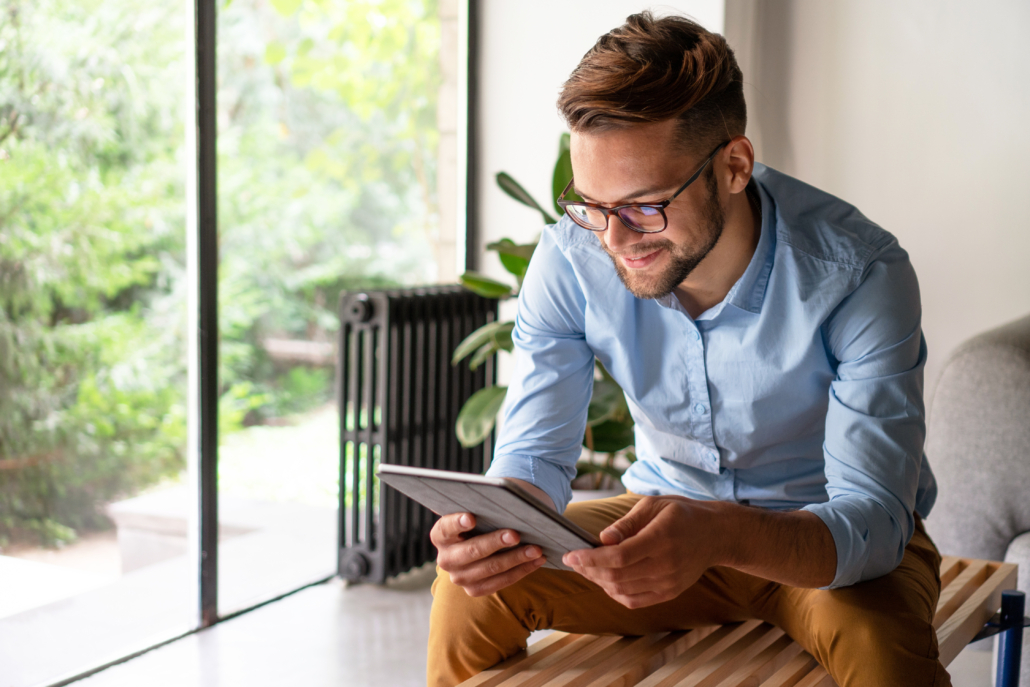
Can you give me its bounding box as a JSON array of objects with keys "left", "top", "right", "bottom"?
[{"left": 0, "top": 0, "right": 185, "bottom": 543}]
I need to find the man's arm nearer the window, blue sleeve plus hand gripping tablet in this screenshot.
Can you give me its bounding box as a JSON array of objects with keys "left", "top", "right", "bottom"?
[{"left": 431, "top": 225, "right": 593, "bottom": 596}]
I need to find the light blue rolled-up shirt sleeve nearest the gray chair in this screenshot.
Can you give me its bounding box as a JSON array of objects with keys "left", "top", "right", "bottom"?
[{"left": 804, "top": 241, "right": 926, "bottom": 588}]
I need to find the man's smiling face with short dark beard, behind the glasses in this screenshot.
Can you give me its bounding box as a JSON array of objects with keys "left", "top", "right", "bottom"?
[{"left": 572, "top": 121, "right": 725, "bottom": 299}]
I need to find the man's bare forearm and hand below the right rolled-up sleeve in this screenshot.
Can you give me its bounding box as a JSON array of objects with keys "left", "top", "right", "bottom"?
[{"left": 563, "top": 496, "right": 836, "bottom": 609}]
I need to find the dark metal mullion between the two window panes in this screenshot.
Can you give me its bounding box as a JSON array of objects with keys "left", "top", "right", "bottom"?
[{"left": 195, "top": 0, "right": 218, "bottom": 627}]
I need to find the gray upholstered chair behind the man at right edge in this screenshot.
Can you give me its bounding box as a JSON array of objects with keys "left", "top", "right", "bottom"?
[{"left": 926, "top": 316, "right": 1030, "bottom": 687}]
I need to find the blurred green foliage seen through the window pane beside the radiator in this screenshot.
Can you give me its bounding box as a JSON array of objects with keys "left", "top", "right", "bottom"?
[{"left": 218, "top": 0, "right": 440, "bottom": 428}]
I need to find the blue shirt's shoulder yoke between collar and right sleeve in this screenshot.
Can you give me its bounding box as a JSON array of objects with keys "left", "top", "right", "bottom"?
[{"left": 754, "top": 164, "right": 897, "bottom": 273}]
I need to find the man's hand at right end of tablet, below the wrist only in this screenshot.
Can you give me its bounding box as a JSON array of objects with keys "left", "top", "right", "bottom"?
[{"left": 562, "top": 496, "right": 719, "bottom": 609}]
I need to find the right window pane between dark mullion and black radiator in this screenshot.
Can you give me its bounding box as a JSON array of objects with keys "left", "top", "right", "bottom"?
[{"left": 217, "top": 0, "right": 453, "bottom": 612}]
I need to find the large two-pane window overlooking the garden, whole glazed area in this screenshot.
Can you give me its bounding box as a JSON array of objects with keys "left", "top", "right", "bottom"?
[{"left": 0, "top": 0, "right": 464, "bottom": 687}]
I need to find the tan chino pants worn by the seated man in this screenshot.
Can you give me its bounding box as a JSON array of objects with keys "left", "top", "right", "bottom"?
[{"left": 427, "top": 493, "right": 952, "bottom": 687}]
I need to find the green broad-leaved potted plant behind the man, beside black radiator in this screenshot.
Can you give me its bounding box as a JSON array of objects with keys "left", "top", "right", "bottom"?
[{"left": 451, "top": 134, "right": 636, "bottom": 497}]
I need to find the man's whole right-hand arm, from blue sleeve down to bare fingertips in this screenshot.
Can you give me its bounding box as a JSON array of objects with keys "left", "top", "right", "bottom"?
[{"left": 567, "top": 241, "right": 926, "bottom": 607}]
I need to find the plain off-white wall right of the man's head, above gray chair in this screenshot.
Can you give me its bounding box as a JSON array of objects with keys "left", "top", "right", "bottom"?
[{"left": 726, "top": 0, "right": 1030, "bottom": 398}]
